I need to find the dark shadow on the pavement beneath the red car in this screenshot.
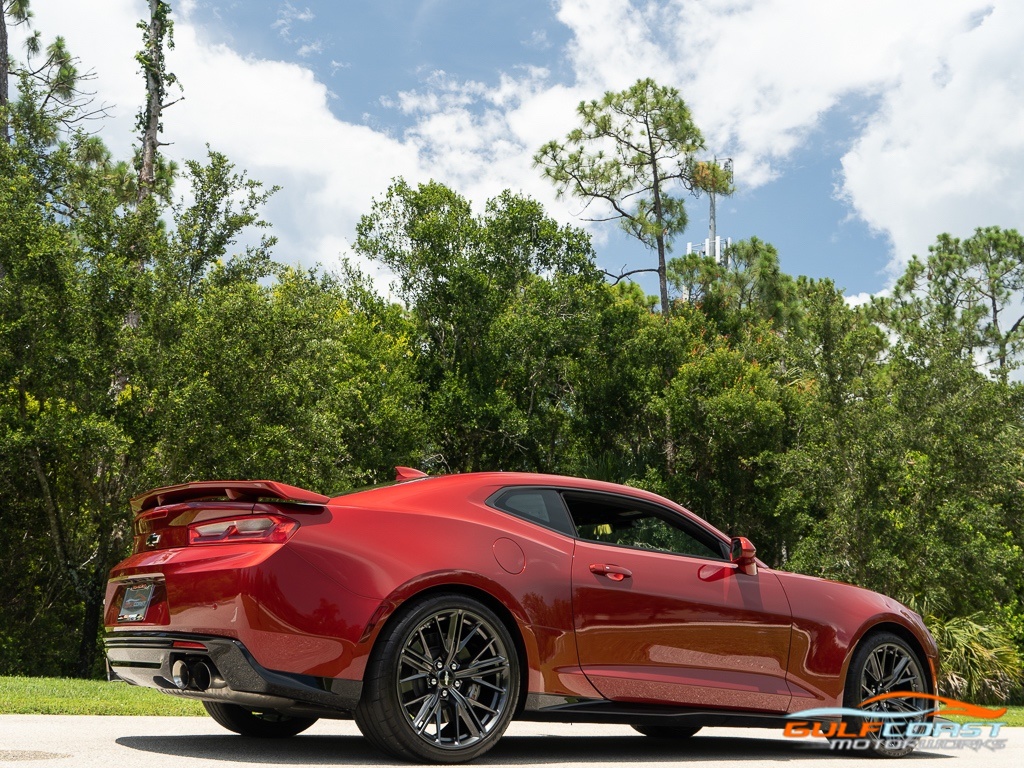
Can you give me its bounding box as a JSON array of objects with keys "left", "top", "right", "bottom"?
[{"left": 117, "top": 734, "right": 950, "bottom": 766}]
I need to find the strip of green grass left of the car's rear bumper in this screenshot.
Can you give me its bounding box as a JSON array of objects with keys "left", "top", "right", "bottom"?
[{"left": 0, "top": 677, "right": 206, "bottom": 716}]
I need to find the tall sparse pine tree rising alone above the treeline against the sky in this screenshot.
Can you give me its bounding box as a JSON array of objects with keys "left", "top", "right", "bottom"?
[{"left": 534, "top": 78, "right": 731, "bottom": 314}]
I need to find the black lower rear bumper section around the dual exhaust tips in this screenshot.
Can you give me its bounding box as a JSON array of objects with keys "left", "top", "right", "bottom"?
[{"left": 103, "top": 632, "right": 362, "bottom": 718}]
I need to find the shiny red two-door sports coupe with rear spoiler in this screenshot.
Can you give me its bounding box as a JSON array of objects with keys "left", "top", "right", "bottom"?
[{"left": 104, "top": 468, "right": 937, "bottom": 763}]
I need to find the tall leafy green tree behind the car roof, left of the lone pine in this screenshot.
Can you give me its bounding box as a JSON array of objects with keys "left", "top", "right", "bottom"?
[{"left": 356, "top": 180, "right": 605, "bottom": 471}]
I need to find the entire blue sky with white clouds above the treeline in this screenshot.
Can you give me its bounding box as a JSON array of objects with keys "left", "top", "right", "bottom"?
[{"left": 9, "top": 0, "right": 1024, "bottom": 303}]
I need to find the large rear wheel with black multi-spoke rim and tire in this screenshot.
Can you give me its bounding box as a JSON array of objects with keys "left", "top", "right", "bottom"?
[{"left": 355, "top": 594, "right": 519, "bottom": 763}]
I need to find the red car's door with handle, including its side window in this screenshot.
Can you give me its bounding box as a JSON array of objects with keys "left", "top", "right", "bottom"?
[{"left": 562, "top": 492, "right": 792, "bottom": 712}]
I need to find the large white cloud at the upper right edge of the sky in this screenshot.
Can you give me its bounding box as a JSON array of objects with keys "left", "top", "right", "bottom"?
[{"left": 843, "top": 2, "right": 1024, "bottom": 270}]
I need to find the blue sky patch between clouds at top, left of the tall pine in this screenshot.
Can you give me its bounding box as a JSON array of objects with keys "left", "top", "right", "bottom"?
[{"left": 193, "top": 0, "right": 571, "bottom": 123}]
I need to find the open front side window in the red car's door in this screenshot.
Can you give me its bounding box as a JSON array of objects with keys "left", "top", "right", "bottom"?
[{"left": 563, "top": 493, "right": 727, "bottom": 560}]
